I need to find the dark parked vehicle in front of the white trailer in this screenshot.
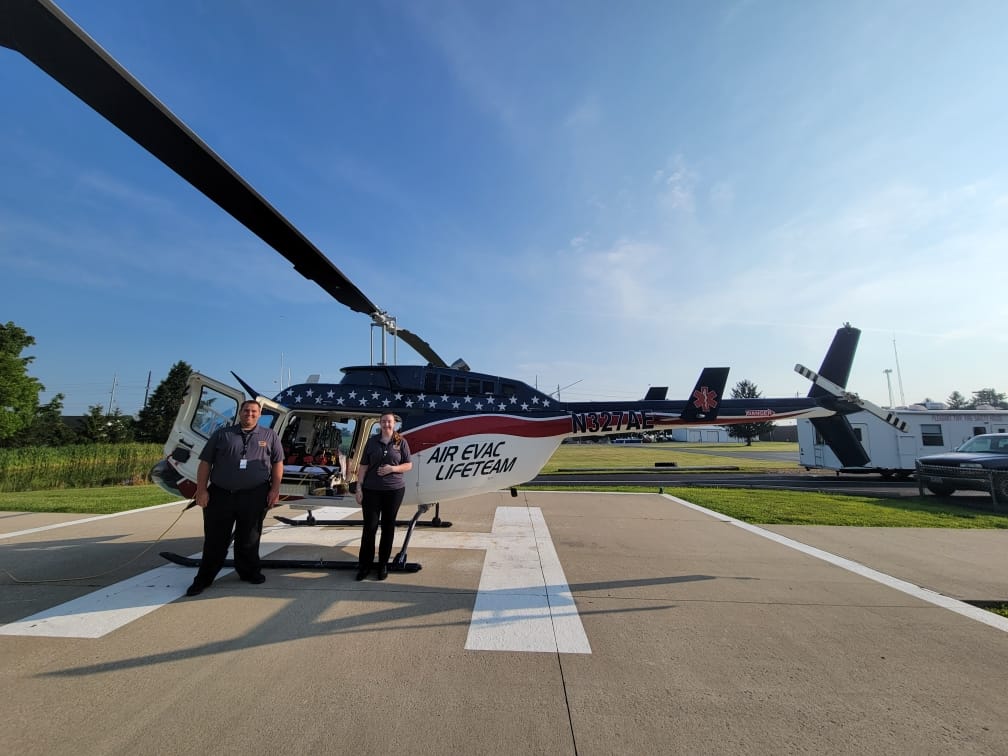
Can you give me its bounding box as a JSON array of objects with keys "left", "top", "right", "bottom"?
[{"left": 916, "top": 433, "right": 1008, "bottom": 505}]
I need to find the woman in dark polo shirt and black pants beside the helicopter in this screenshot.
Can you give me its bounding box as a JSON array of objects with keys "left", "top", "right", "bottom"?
[{"left": 356, "top": 412, "right": 413, "bottom": 581}]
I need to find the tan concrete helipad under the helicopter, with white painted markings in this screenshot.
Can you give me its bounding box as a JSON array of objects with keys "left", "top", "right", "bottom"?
[{"left": 0, "top": 492, "right": 1008, "bottom": 754}]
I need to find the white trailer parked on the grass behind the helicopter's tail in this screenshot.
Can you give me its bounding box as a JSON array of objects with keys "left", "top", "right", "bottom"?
[{"left": 797, "top": 411, "right": 1008, "bottom": 478}]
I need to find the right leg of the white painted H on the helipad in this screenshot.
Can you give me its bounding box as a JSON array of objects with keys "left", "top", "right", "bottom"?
[{"left": 466, "top": 507, "right": 592, "bottom": 653}]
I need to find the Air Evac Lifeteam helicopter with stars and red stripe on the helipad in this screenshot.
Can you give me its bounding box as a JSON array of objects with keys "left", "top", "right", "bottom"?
[{"left": 0, "top": 0, "right": 901, "bottom": 570}]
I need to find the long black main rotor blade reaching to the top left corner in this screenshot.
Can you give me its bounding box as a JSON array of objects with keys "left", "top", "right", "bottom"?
[{"left": 0, "top": 0, "right": 379, "bottom": 316}]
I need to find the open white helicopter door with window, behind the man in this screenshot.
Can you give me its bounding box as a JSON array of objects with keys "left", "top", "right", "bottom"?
[{"left": 164, "top": 373, "right": 289, "bottom": 495}]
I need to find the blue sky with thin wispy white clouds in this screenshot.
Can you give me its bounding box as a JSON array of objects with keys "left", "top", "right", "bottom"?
[{"left": 0, "top": 0, "right": 1008, "bottom": 413}]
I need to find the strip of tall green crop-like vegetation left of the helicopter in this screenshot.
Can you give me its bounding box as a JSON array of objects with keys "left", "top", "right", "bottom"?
[{"left": 0, "top": 444, "right": 163, "bottom": 493}]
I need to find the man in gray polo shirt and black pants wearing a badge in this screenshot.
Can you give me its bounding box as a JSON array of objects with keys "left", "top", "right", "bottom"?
[{"left": 185, "top": 399, "right": 283, "bottom": 596}]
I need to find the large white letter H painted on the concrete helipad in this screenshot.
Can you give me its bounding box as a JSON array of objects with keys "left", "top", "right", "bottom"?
[{"left": 0, "top": 507, "right": 592, "bottom": 653}]
